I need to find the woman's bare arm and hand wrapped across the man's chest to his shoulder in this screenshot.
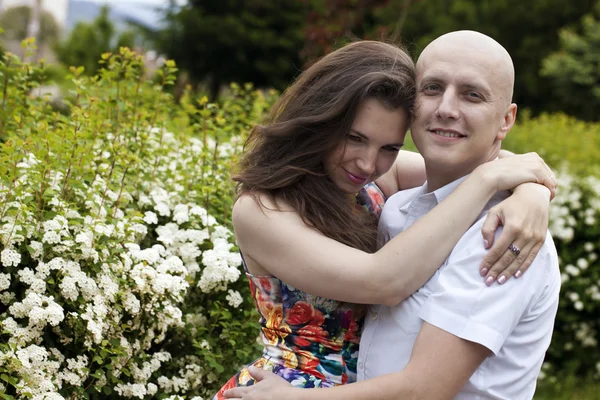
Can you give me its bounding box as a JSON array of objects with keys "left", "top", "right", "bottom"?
[{"left": 233, "top": 155, "right": 554, "bottom": 305}]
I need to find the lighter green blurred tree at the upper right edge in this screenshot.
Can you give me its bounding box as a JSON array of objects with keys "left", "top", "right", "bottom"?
[{"left": 541, "top": 1, "right": 600, "bottom": 121}]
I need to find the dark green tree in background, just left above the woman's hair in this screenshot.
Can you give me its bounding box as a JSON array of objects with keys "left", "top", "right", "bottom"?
[{"left": 159, "top": 0, "right": 306, "bottom": 100}]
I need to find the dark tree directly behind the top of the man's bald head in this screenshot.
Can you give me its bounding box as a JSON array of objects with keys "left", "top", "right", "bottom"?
[{"left": 378, "top": 0, "right": 597, "bottom": 117}]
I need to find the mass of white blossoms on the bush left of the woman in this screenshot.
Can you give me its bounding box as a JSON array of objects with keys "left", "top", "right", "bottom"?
[{"left": 0, "top": 124, "right": 248, "bottom": 400}]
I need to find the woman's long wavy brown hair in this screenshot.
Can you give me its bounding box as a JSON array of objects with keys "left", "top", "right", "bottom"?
[{"left": 233, "top": 41, "right": 415, "bottom": 252}]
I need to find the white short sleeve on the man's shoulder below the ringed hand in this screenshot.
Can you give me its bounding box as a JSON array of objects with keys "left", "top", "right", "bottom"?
[{"left": 419, "top": 219, "right": 551, "bottom": 354}]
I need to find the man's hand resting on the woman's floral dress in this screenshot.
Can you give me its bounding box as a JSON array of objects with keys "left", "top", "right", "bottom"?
[{"left": 224, "top": 367, "right": 295, "bottom": 400}]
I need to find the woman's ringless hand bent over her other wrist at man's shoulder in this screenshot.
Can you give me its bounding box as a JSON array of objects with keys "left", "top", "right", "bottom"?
[{"left": 473, "top": 153, "right": 558, "bottom": 199}]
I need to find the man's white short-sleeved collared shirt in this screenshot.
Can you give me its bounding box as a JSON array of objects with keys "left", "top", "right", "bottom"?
[{"left": 358, "top": 178, "right": 561, "bottom": 400}]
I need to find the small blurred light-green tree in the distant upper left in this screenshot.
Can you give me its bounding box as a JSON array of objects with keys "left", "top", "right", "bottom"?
[{"left": 55, "top": 6, "right": 134, "bottom": 75}]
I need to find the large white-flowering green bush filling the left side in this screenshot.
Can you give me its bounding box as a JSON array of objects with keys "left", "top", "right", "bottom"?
[{"left": 0, "top": 44, "right": 268, "bottom": 399}]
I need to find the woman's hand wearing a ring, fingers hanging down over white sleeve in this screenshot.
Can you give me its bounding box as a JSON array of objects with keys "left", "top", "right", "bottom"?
[{"left": 480, "top": 183, "right": 550, "bottom": 286}]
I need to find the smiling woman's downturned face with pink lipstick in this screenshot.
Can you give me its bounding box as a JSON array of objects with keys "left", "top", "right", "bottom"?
[{"left": 325, "top": 99, "right": 409, "bottom": 194}]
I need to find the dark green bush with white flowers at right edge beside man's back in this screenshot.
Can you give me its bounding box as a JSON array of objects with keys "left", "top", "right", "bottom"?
[{"left": 540, "top": 171, "right": 600, "bottom": 384}]
